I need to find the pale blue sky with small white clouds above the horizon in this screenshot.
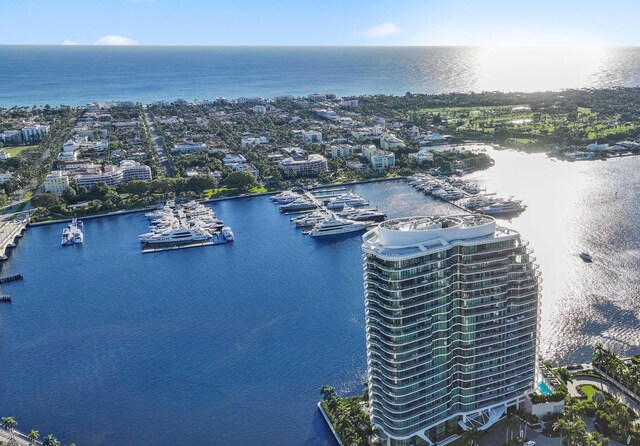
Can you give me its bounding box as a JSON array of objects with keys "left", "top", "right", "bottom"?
[{"left": 0, "top": 0, "right": 640, "bottom": 46}]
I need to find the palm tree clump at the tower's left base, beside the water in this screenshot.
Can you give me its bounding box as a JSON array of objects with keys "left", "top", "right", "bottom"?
[{"left": 320, "top": 386, "right": 375, "bottom": 446}]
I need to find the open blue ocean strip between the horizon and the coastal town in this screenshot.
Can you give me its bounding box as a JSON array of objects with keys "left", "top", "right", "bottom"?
[{"left": 0, "top": 46, "right": 640, "bottom": 107}]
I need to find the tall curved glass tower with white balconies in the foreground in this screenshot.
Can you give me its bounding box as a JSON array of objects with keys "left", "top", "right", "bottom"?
[{"left": 363, "top": 214, "right": 540, "bottom": 446}]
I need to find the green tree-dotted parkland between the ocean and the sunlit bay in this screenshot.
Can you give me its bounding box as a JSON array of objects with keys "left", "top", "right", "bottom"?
[{"left": 360, "top": 88, "right": 640, "bottom": 151}]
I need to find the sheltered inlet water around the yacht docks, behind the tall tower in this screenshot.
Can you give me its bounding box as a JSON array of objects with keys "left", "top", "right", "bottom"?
[{"left": 0, "top": 149, "right": 640, "bottom": 446}]
